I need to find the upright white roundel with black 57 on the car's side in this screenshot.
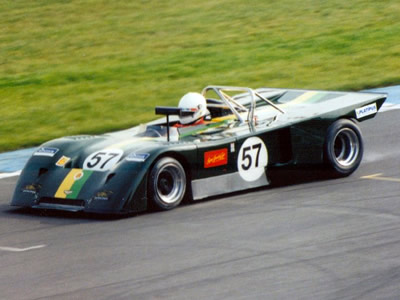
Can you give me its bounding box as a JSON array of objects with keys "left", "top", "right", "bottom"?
[{"left": 237, "top": 137, "right": 268, "bottom": 181}]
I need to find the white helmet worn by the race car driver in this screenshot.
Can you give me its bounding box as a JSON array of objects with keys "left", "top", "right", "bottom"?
[{"left": 178, "top": 93, "right": 208, "bottom": 124}]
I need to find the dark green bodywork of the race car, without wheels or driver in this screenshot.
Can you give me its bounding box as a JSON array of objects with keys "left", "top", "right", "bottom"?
[{"left": 11, "top": 88, "right": 386, "bottom": 213}]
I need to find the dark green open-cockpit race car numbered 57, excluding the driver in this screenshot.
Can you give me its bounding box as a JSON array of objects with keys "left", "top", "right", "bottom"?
[{"left": 11, "top": 86, "right": 386, "bottom": 213}]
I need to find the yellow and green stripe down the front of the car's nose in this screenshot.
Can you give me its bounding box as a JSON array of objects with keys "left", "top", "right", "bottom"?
[{"left": 54, "top": 169, "right": 93, "bottom": 199}]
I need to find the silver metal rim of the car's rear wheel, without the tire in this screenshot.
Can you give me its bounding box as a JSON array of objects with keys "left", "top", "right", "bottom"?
[{"left": 333, "top": 128, "right": 360, "bottom": 167}]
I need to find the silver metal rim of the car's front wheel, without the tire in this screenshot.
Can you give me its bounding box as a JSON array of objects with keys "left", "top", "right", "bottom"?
[{"left": 154, "top": 164, "right": 185, "bottom": 204}]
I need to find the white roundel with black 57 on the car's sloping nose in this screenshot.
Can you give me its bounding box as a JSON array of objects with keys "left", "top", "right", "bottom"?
[{"left": 83, "top": 149, "right": 124, "bottom": 172}]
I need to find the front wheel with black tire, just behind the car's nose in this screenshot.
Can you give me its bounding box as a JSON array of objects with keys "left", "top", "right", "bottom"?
[{"left": 148, "top": 157, "right": 186, "bottom": 210}]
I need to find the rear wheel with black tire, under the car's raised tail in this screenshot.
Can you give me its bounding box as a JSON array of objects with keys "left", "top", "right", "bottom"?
[{"left": 324, "top": 119, "right": 364, "bottom": 177}]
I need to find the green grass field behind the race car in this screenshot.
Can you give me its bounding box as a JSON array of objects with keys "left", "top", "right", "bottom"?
[{"left": 0, "top": 0, "right": 400, "bottom": 151}]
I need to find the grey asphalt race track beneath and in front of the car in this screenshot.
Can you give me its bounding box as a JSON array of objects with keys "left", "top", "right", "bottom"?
[{"left": 0, "top": 110, "right": 400, "bottom": 300}]
